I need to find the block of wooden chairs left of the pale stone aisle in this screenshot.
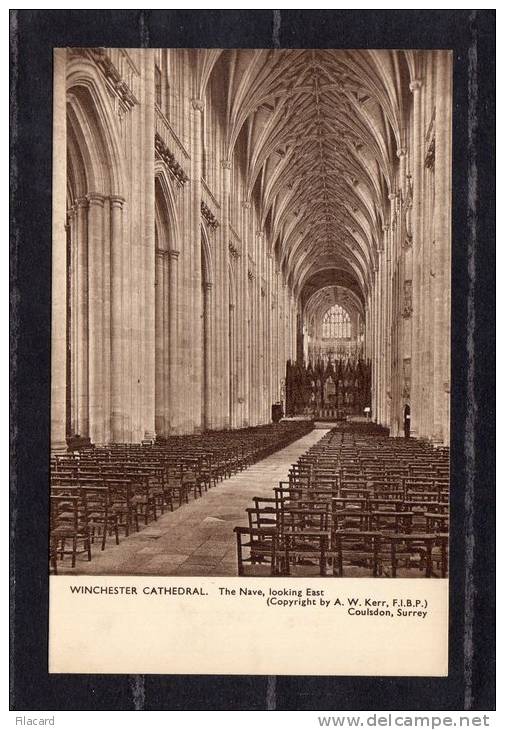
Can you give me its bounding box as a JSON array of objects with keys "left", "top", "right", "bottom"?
[{"left": 50, "top": 422, "right": 311, "bottom": 573}]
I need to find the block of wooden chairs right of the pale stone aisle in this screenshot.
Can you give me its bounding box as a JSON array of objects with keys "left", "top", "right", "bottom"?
[{"left": 235, "top": 428, "right": 449, "bottom": 577}]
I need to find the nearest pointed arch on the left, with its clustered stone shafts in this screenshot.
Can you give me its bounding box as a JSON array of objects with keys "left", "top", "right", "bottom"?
[{"left": 66, "top": 54, "right": 127, "bottom": 443}]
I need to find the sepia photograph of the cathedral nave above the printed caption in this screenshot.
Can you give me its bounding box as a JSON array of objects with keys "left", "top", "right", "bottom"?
[{"left": 49, "top": 47, "right": 453, "bottom": 585}]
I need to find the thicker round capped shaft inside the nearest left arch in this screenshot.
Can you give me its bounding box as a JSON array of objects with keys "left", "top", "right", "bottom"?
[{"left": 88, "top": 193, "right": 105, "bottom": 444}]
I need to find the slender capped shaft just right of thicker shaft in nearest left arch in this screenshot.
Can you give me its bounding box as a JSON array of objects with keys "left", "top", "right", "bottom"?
[{"left": 110, "top": 195, "right": 125, "bottom": 443}]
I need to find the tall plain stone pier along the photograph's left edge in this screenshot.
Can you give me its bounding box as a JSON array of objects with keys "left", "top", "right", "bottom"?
[{"left": 51, "top": 48, "right": 67, "bottom": 451}]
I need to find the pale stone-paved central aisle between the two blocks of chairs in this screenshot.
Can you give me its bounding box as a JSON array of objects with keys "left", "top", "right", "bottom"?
[{"left": 66, "top": 429, "right": 327, "bottom": 576}]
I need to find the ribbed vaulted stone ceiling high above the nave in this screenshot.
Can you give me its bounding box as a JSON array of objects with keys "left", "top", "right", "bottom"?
[{"left": 199, "top": 50, "right": 418, "bottom": 322}]
